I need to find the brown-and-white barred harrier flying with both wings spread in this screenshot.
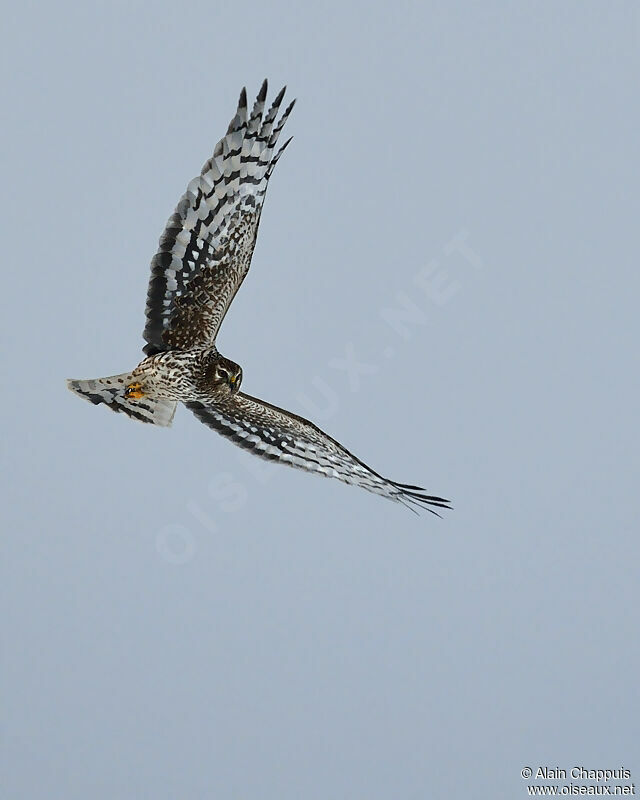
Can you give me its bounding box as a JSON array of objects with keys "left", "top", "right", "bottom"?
[{"left": 67, "top": 80, "right": 450, "bottom": 514}]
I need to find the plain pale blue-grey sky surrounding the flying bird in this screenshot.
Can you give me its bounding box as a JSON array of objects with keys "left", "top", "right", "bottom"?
[{"left": 0, "top": 0, "right": 640, "bottom": 800}]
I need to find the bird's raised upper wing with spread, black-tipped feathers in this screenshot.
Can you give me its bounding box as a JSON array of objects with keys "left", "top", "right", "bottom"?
[{"left": 143, "top": 81, "right": 295, "bottom": 355}]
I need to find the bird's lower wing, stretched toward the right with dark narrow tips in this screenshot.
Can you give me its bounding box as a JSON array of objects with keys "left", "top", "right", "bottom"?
[{"left": 187, "top": 392, "right": 450, "bottom": 514}]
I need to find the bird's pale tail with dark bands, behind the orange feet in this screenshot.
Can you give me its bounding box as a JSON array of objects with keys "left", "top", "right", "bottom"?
[{"left": 67, "top": 372, "right": 177, "bottom": 427}]
